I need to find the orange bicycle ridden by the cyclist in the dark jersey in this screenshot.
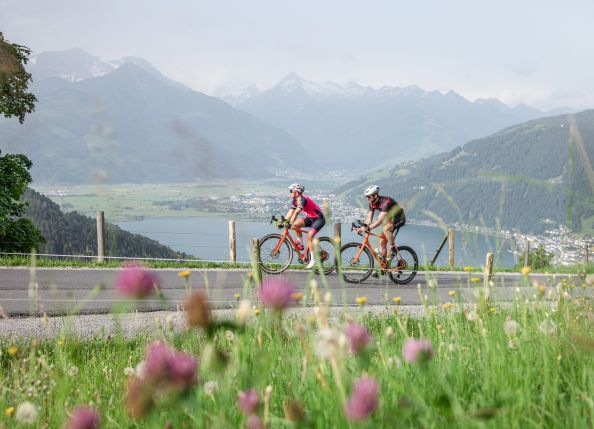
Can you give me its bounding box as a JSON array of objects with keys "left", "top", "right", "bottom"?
[{"left": 336, "top": 220, "right": 419, "bottom": 284}]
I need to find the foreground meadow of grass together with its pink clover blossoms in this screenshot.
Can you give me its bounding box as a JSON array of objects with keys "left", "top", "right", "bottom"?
[{"left": 0, "top": 268, "right": 594, "bottom": 428}]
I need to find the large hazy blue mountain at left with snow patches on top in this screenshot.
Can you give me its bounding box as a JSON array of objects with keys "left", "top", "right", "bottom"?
[{"left": 0, "top": 50, "right": 316, "bottom": 183}]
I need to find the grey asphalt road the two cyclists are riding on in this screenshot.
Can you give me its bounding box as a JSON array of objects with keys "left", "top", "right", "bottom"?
[{"left": 0, "top": 268, "right": 591, "bottom": 316}]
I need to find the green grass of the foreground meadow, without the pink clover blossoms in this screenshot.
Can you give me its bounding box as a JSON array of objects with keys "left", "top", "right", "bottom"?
[{"left": 0, "top": 285, "right": 594, "bottom": 429}]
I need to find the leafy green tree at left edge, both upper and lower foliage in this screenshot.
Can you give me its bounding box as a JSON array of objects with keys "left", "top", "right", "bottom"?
[{"left": 0, "top": 33, "right": 45, "bottom": 252}]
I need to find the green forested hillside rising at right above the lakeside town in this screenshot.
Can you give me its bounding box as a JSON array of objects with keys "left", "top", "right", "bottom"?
[{"left": 338, "top": 110, "right": 594, "bottom": 233}]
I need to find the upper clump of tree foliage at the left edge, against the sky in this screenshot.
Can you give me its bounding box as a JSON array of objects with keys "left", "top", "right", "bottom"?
[{"left": 0, "top": 32, "right": 37, "bottom": 124}]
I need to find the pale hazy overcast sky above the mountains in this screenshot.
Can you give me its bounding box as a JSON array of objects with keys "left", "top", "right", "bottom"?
[{"left": 0, "top": 0, "right": 594, "bottom": 110}]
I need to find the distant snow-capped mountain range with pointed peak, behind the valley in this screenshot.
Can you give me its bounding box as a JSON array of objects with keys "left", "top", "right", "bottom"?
[{"left": 216, "top": 73, "right": 566, "bottom": 170}]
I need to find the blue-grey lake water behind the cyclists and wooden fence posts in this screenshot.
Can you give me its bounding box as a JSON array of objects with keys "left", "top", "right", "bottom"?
[{"left": 118, "top": 216, "right": 516, "bottom": 267}]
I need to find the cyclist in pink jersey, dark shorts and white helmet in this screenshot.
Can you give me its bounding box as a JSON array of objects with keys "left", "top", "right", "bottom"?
[{"left": 285, "top": 183, "right": 326, "bottom": 268}]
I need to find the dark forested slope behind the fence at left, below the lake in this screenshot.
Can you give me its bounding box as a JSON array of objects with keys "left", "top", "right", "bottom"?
[{"left": 23, "top": 189, "right": 188, "bottom": 258}]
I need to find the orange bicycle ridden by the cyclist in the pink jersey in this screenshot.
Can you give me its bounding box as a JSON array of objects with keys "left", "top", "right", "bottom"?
[{"left": 259, "top": 215, "right": 336, "bottom": 274}]
